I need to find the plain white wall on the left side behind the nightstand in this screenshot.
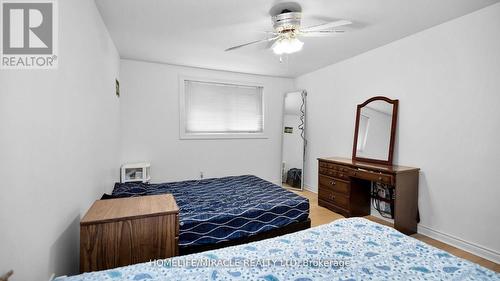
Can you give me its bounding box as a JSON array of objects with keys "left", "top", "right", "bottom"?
[{"left": 0, "top": 0, "right": 119, "bottom": 281}]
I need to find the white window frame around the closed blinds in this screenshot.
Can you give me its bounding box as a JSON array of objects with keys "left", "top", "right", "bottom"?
[{"left": 179, "top": 75, "right": 268, "bottom": 140}]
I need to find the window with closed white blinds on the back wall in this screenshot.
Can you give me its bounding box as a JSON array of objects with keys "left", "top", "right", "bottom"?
[{"left": 180, "top": 79, "right": 264, "bottom": 138}]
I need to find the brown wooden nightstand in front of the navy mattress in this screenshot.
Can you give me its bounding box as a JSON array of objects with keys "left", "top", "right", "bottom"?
[{"left": 80, "top": 194, "right": 179, "bottom": 272}]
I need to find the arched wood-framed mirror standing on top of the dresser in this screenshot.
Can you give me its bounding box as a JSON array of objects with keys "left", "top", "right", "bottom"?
[{"left": 352, "top": 97, "right": 399, "bottom": 165}]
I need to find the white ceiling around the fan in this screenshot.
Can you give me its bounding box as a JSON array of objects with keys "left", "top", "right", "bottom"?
[{"left": 96, "top": 0, "right": 500, "bottom": 77}]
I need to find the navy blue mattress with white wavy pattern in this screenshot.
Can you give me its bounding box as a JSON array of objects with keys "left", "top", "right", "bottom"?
[{"left": 112, "top": 175, "right": 309, "bottom": 248}]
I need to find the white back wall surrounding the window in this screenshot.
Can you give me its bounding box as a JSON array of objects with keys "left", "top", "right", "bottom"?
[{"left": 120, "top": 60, "right": 293, "bottom": 182}]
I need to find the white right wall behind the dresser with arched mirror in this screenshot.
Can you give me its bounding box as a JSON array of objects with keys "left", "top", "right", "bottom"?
[{"left": 296, "top": 4, "right": 500, "bottom": 262}]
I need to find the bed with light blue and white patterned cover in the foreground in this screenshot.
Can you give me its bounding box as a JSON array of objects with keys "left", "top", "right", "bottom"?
[{"left": 56, "top": 218, "right": 500, "bottom": 281}]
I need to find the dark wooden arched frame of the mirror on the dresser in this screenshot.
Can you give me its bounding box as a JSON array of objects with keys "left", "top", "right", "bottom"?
[{"left": 352, "top": 96, "right": 399, "bottom": 165}]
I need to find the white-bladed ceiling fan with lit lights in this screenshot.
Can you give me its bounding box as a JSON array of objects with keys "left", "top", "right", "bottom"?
[{"left": 225, "top": 3, "right": 352, "bottom": 55}]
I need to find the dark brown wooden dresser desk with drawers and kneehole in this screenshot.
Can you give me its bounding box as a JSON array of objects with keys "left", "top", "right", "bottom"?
[{"left": 318, "top": 157, "right": 420, "bottom": 235}]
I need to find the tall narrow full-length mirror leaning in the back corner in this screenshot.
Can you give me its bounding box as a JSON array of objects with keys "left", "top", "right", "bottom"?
[{"left": 281, "top": 91, "right": 307, "bottom": 190}]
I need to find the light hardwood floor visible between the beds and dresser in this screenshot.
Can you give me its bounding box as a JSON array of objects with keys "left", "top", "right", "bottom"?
[{"left": 291, "top": 190, "right": 500, "bottom": 272}]
